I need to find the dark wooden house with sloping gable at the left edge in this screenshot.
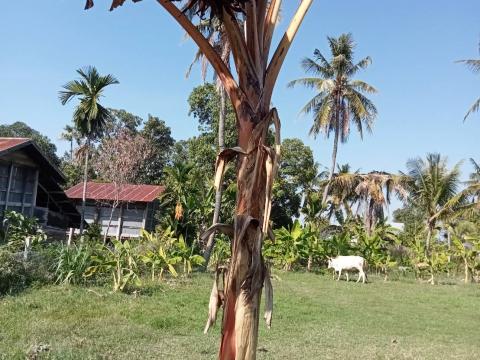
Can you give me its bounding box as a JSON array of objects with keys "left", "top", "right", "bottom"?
[{"left": 0, "top": 137, "right": 80, "bottom": 234}]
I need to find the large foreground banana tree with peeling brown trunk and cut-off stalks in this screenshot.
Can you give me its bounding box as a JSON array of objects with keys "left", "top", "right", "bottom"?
[{"left": 86, "top": 0, "right": 313, "bottom": 360}]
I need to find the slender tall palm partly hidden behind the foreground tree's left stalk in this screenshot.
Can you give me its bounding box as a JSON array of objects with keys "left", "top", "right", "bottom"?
[{"left": 187, "top": 17, "right": 231, "bottom": 267}]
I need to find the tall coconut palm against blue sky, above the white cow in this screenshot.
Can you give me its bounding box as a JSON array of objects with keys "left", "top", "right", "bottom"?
[{"left": 288, "top": 34, "right": 377, "bottom": 203}]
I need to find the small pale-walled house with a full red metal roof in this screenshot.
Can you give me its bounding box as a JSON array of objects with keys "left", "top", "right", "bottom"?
[{"left": 66, "top": 182, "right": 165, "bottom": 238}]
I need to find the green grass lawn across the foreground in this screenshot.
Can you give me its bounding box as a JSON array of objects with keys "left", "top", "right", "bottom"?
[{"left": 0, "top": 273, "right": 480, "bottom": 359}]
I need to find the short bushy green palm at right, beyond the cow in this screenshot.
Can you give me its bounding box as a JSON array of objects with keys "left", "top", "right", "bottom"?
[{"left": 405, "top": 153, "right": 465, "bottom": 255}]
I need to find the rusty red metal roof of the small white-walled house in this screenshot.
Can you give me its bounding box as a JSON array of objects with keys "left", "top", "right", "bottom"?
[{"left": 65, "top": 181, "right": 165, "bottom": 202}]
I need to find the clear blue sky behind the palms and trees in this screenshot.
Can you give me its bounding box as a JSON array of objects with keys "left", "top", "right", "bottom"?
[{"left": 0, "top": 0, "right": 480, "bottom": 183}]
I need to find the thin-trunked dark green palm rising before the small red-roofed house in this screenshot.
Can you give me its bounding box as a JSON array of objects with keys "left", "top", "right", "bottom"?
[{"left": 59, "top": 66, "right": 118, "bottom": 235}]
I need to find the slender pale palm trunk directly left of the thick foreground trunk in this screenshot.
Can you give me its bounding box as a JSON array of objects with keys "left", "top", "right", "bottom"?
[{"left": 203, "top": 86, "right": 227, "bottom": 267}]
